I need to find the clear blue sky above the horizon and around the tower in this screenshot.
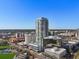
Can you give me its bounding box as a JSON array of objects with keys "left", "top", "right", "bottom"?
[{"left": 0, "top": 0, "right": 79, "bottom": 29}]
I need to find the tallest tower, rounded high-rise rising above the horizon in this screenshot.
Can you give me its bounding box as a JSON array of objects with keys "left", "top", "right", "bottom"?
[{"left": 36, "top": 17, "right": 48, "bottom": 51}]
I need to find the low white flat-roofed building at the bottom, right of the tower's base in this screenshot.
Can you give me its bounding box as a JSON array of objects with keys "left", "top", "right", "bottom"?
[{"left": 45, "top": 47, "right": 66, "bottom": 59}]
